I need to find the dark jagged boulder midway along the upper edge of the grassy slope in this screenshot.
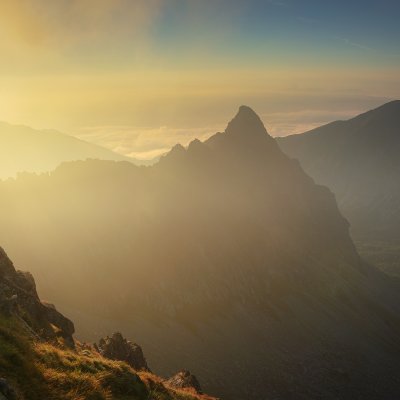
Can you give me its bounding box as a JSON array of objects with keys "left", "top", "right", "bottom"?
[{"left": 98, "top": 332, "right": 150, "bottom": 371}]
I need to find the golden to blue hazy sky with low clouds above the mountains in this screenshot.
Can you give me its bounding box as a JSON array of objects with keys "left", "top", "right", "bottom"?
[{"left": 0, "top": 0, "right": 400, "bottom": 159}]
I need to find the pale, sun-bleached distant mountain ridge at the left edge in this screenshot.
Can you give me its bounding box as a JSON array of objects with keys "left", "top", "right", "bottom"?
[{"left": 0, "top": 122, "right": 150, "bottom": 179}]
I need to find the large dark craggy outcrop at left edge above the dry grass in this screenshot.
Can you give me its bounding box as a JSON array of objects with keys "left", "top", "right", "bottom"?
[{"left": 0, "top": 248, "right": 75, "bottom": 347}]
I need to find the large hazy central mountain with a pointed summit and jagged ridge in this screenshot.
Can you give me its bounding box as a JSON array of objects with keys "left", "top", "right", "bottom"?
[{"left": 0, "top": 107, "right": 400, "bottom": 400}]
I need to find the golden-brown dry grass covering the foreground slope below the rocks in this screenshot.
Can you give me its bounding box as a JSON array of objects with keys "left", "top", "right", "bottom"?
[{"left": 0, "top": 316, "right": 219, "bottom": 400}]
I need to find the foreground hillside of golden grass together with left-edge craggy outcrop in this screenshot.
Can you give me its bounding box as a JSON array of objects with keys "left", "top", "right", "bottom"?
[{"left": 0, "top": 248, "right": 215, "bottom": 400}]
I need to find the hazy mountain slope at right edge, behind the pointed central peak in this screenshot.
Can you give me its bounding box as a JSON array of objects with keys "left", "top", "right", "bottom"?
[{"left": 278, "top": 101, "right": 400, "bottom": 272}]
